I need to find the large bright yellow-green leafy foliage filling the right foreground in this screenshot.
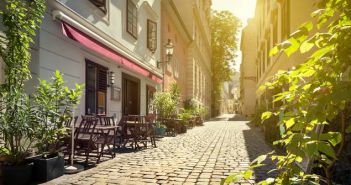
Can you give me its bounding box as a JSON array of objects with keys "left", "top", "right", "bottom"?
[{"left": 227, "top": 0, "right": 351, "bottom": 184}]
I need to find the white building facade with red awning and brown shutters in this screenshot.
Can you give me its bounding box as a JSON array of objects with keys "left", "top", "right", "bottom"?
[{"left": 27, "top": 0, "right": 163, "bottom": 118}]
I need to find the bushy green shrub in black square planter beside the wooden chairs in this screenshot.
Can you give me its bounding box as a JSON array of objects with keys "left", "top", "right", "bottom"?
[{"left": 32, "top": 71, "right": 83, "bottom": 182}]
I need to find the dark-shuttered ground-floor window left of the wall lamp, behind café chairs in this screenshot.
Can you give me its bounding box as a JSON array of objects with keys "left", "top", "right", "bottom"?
[{"left": 85, "top": 60, "right": 107, "bottom": 115}]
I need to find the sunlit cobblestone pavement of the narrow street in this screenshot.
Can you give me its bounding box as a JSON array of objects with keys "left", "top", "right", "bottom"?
[{"left": 47, "top": 115, "right": 271, "bottom": 184}]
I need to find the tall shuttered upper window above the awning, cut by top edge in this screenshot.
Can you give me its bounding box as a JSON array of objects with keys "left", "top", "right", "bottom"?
[{"left": 127, "top": 0, "right": 138, "bottom": 39}]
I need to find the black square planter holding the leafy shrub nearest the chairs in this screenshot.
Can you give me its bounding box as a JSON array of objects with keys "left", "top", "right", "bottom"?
[{"left": 31, "top": 155, "right": 65, "bottom": 182}]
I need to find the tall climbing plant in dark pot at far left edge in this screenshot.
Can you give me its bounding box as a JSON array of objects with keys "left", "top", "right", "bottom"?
[{"left": 0, "top": 0, "right": 46, "bottom": 185}]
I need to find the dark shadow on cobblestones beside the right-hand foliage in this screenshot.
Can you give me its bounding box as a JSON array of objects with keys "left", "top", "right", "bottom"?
[{"left": 243, "top": 124, "right": 276, "bottom": 182}]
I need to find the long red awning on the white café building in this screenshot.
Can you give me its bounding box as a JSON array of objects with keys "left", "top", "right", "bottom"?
[{"left": 62, "top": 21, "right": 162, "bottom": 83}]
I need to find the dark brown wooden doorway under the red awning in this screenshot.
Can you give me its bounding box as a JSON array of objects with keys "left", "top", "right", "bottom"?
[{"left": 122, "top": 73, "right": 140, "bottom": 115}]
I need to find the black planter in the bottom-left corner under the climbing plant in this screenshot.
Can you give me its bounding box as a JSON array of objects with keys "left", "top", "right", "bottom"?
[{"left": 2, "top": 163, "right": 34, "bottom": 185}]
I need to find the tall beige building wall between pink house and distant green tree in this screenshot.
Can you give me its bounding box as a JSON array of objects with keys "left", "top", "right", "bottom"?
[{"left": 169, "top": 0, "right": 212, "bottom": 116}]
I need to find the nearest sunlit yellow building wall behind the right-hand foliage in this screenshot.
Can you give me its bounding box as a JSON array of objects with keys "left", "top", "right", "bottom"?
[{"left": 255, "top": 0, "right": 318, "bottom": 108}]
